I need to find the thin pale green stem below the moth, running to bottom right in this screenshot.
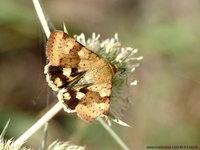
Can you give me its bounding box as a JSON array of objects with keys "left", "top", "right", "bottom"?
[{"left": 97, "top": 117, "right": 130, "bottom": 150}]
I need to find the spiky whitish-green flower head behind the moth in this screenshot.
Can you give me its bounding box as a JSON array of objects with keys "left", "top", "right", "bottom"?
[{"left": 74, "top": 33, "right": 143, "bottom": 119}]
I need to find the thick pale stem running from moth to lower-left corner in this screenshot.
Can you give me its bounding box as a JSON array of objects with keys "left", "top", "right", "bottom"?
[{"left": 13, "top": 102, "right": 63, "bottom": 145}]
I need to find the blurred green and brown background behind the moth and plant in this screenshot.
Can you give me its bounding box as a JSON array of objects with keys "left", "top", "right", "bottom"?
[{"left": 0, "top": 0, "right": 200, "bottom": 150}]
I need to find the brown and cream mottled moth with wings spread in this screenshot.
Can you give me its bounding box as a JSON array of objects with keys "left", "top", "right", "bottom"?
[{"left": 44, "top": 30, "right": 116, "bottom": 122}]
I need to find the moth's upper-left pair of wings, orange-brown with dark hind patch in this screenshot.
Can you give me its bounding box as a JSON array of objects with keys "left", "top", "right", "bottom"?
[{"left": 45, "top": 31, "right": 99, "bottom": 91}]
